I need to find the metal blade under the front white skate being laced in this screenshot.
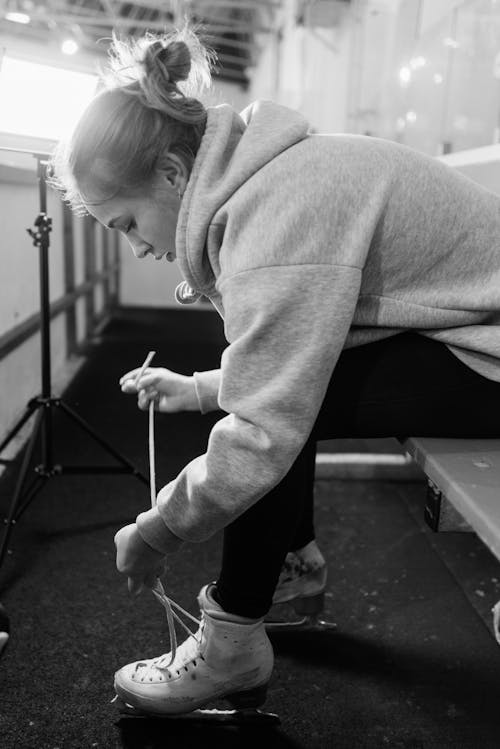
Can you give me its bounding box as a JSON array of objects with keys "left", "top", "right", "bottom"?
[{"left": 111, "top": 695, "right": 281, "bottom": 725}]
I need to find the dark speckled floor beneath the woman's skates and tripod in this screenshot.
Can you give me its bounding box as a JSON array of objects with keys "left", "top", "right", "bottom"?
[{"left": 0, "top": 310, "right": 500, "bottom": 749}]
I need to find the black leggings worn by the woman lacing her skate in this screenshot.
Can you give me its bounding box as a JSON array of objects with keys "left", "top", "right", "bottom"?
[{"left": 217, "top": 333, "right": 500, "bottom": 617}]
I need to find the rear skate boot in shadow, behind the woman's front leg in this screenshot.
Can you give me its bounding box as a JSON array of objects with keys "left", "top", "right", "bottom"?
[{"left": 265, "top": 541, "right": 330, "bottom": 631}]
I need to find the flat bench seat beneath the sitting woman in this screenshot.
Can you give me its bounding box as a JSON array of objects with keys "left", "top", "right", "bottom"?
[{"left": 404, "top": 437, "right": 500, "bottom": 559}]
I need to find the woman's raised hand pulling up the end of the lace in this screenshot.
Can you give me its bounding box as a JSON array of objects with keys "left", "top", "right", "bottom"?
[{"left": 120, "top": 367, "right": 200, "bottom": 413}]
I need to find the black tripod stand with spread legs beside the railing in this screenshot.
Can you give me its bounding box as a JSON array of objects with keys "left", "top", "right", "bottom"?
[{"left": 0, "top": 149, "right": 149, "bottom": 566}]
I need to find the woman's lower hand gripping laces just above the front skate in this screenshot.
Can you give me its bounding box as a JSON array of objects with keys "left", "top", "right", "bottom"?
[{"left": 115, "top": 523, "right": 165, "bottom": 596}]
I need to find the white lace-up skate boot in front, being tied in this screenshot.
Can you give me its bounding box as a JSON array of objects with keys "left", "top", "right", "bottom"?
[{"left": 115, "top": 584, "right": 274, "bottom": 716}]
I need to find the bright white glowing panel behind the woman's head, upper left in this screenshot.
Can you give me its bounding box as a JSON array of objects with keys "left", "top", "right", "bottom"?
[{"left": 0, "top": 55, "right": 97, "bottom": 140}]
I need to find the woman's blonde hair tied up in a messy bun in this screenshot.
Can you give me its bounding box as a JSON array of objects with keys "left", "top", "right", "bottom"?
[{"left": 49, "top": 26, "right": 213, "bottom": 215}]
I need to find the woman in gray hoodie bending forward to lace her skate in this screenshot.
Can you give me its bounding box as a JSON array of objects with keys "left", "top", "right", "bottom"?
[{"left": 49, "top": 23, "right": 500, "bottom": 713}]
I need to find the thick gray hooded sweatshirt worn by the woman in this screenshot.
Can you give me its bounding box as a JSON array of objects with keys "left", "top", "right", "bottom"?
[{"left": 137, "top": 102, "right": 500, "bottom": 553}]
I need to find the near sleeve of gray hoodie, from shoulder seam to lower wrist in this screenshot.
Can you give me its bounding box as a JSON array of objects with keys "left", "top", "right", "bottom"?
[{"left": 139, "top": 264, "right": 361, "bottom": 553}]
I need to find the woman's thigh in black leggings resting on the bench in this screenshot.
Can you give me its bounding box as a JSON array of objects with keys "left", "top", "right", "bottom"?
[{"left": 313, "top": 333, "right": 500, "bottom": 440}]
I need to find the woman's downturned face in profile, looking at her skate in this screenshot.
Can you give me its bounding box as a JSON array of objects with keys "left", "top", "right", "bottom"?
[{"left": 85, "top": 153, "right": 187, "bottom": 261}]
